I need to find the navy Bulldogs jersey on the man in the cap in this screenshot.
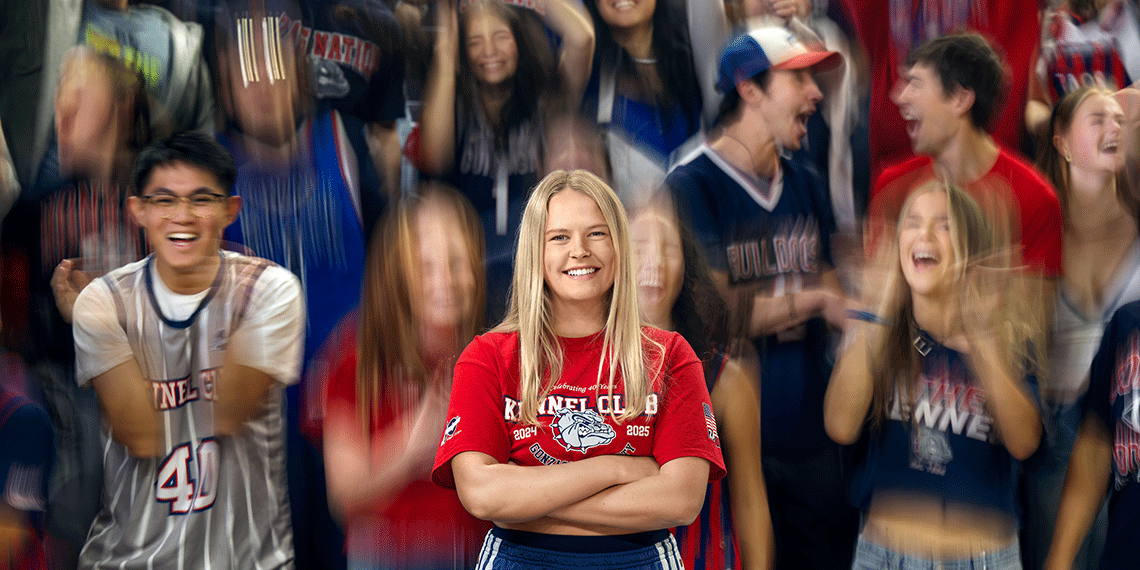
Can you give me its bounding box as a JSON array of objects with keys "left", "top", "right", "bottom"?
[{"left": 665, "top": 145, "right": 834, "bottom": 454}]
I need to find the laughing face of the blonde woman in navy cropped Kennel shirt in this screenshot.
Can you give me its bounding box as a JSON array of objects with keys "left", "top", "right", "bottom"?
[{"left": 898, "top": 188, "right": 956, "bottom": 301}]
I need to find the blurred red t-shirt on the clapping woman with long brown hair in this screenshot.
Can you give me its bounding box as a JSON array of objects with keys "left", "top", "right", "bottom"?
[{"left": 327, "top": 350, "right": 491, "bottom": 568}]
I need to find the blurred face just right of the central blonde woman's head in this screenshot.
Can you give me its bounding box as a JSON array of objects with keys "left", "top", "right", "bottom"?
[{"left": 629, "top": 211, "right": 685, "bottom": 328}]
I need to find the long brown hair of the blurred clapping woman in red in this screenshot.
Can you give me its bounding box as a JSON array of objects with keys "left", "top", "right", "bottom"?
[{"left": 357, "top": 185, "right": 487, "bottom": 431}]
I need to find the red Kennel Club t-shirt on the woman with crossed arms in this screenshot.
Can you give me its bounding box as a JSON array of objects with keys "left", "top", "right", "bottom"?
[{"left": 432, "top": 327, "right": 725, "bottom": 488}]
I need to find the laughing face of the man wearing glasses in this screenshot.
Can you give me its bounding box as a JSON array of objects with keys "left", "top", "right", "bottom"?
[{"left": 128, "top": 162, "right": 242, "bottom": 293}]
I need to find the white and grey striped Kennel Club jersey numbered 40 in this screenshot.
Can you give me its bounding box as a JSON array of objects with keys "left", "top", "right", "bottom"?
[{"left": 74, "top": 253, "right": 303, "bottom": 570}]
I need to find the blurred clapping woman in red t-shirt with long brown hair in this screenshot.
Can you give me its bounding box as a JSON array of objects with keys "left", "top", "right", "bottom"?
[{"left": 324, "top": 186, "right": 488, "bottom": 570}]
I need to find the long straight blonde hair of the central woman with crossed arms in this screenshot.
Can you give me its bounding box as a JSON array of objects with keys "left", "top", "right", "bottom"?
[{"left": 495, "top": 170, "right": 662, "bottom": 424}]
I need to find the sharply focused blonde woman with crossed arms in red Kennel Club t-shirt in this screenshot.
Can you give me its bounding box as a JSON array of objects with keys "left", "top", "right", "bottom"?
[{"left": 432, "top": 170, "right": 724, "bottom": 569}]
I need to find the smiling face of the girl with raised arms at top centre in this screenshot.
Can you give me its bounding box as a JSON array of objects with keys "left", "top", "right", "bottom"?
[{"left": 464, "top": 7, "right": 519, "bottom": 86}]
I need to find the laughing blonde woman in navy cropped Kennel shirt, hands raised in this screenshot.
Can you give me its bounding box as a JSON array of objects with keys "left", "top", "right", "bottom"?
[{"left": 824, "top": 181, "right": 1042, "bottom": 570}]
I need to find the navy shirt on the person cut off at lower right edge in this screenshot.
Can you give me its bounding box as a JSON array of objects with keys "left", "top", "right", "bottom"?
[{"left": 1081, "top": 301, "right": 1140, "bottom": 569}]
